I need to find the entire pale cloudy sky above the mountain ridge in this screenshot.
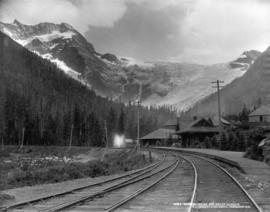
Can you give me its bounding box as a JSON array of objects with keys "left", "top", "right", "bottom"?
[{"left": 0, "top": 0, "right": 270, "bottom": 64}]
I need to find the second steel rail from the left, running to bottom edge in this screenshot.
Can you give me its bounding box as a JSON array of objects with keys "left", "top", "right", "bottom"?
[{"left": 42, "top": 155, "right": 178, "bottom": 212}]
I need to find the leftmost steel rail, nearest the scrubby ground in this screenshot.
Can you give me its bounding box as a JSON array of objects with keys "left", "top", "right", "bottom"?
[{"left": 0, "top": 154, "right": 166, "bottom": 211}]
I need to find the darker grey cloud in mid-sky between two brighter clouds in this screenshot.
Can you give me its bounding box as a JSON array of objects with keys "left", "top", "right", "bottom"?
[{"left": 86, "top": 0, "right": 188, "bottom": 61}]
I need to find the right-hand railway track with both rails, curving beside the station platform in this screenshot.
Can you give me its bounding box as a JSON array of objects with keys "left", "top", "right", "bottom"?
[{"left": 179, "top": 153, "right": 262, "bottom": 212}]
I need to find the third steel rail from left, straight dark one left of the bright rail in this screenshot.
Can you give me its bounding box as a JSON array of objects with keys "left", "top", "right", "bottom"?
[{"left": 105, "top": 160, "right": 179, "bottom": 212}]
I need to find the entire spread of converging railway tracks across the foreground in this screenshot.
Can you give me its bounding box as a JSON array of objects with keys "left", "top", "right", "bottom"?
[{"left": 2, "top": 149, "right": 262, "bottom": 212}]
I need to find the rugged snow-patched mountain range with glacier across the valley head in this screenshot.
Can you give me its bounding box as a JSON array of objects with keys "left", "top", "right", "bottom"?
[{"left": 0, "top": 20, "right": 259, "bottom": 110}]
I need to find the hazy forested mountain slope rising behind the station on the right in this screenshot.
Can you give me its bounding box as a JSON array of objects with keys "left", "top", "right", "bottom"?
[{"left": 189, "top": 48, "right": 270, "bottom": 115}]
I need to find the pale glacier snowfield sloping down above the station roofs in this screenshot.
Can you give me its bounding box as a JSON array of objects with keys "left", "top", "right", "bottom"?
[{"left": 143, "top": 64, "right": 245, "bottom": 111}]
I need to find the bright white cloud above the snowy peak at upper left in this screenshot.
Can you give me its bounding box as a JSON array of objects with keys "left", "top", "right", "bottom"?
[{"left": 0, "top": 0, "right": 127, "bottom": 33}]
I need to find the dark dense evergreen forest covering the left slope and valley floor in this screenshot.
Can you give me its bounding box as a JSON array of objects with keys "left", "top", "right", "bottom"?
[{"left": 0, "top": 32, "right": 175, "bottom": 146}]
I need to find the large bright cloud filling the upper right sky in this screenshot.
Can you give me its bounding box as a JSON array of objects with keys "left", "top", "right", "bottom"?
[{"left": 173, "top": 0, "right": 270, "bottom": 64}]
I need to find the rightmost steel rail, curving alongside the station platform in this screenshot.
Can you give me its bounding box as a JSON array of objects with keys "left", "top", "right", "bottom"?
[{"left": 184, "top": 153, "right": 263, "bottom": 212}]
